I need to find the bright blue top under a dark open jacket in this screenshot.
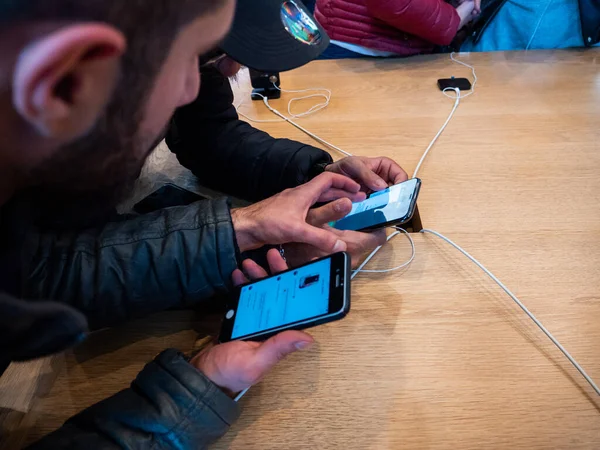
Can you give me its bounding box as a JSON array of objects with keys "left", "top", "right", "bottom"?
[{"left": 461, "top": 0, "right": 584, "bottom": 52}]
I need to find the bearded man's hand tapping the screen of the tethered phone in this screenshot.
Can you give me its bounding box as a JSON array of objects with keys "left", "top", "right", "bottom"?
[{"left": 231, "top": 173, "right": 366, "bottom": 253}]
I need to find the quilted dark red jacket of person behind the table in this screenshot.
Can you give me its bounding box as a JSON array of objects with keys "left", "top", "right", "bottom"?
[{"left": 315, "top": 0, "right": 460, "bottom": 56}]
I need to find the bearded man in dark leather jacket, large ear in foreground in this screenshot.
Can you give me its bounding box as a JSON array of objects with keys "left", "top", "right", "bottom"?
[{"left": 0, "top": 0, "right": 364, "bottom": 449}]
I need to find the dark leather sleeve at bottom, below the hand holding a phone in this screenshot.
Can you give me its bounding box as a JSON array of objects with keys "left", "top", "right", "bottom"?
[{"left": 30, "top": 350, "right": 240, "bottom": 450}]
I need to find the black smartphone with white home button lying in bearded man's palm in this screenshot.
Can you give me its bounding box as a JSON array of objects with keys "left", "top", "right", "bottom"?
[{"left": 219, "top": 252, "right": 350, "bottom": 342}]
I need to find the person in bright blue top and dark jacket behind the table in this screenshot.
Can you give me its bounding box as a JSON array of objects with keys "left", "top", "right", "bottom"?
[{"left": 460, "top": 0, "right": 600, "bottom": 52}]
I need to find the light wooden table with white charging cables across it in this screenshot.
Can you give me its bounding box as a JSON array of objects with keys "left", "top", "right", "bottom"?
[{"left": 16, "top": 50, "right": 600, "bottom": 449}]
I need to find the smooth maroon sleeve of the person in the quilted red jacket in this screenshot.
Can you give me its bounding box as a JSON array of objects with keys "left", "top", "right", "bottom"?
[{"left": 367, "top": 0, "right": 460, "bottom": 45}]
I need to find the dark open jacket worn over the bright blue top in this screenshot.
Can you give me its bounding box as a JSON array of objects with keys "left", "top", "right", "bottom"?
[{"left": 470, "top": 0, "right": 600, "bottom": 47}]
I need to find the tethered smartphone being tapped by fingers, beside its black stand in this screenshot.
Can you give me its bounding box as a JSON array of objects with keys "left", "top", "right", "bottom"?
[{"left": 330, "top": 178, "right": 421, "bottom": 231}]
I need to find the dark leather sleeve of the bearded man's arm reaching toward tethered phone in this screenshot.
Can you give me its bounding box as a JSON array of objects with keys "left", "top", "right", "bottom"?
[{"left": 21, "top": 199, "right": 239, "bottom": 329}]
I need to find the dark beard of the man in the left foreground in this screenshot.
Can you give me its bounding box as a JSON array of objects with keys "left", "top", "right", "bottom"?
[{"left": 26, "top": 73, "right": 163, "bottom": 229}]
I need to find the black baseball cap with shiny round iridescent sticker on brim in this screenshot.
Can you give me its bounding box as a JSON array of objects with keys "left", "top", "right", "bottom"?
[{"left": 221, "top": 0, "right": 329, "bottom": 72}]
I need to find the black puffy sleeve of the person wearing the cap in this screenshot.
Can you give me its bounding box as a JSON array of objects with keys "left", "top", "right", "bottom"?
[{"left": 167, "top": 65, "right": 332, "bottom": 201}]
